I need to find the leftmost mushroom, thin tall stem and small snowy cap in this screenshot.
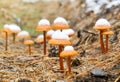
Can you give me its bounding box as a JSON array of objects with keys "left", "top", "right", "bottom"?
[{"left": 2, "top": 24, "right": 10, "bottom": 50}]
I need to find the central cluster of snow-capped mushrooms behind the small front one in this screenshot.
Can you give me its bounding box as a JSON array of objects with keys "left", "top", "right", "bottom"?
[{"left": 36, "top": 17, "right": 77, "bottom": 71}]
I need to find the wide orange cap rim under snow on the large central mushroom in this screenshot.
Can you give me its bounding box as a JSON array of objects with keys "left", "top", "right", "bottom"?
[{"left": 48, "top": 39, "right": 71, "bottom": 46}]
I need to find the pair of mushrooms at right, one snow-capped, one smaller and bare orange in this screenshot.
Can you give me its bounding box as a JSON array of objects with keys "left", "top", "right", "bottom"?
[{"left": 94, "top": 18, "right": 114, "bottom": 53}]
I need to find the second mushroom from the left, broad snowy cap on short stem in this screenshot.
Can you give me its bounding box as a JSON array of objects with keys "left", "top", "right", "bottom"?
[{"left": 9, "top": 24, "right": 21, "bottom": 43}]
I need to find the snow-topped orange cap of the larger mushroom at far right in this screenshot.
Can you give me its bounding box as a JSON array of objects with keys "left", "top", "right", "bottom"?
[{"left": 93, "top": 18, "right": 111, "bottom": 30}]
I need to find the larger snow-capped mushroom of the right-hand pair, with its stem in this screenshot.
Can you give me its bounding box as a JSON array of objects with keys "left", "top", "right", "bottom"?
[{"left": 93, "top": 18, "right": 111, "bottom": 53}]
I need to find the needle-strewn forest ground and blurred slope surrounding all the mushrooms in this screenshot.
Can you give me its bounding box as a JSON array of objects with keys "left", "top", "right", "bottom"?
[{"left": 0, "top": 0, "right": 120, "bottom": 82}]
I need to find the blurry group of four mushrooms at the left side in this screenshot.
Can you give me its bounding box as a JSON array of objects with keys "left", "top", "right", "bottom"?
[{"left": 2, "top": 24, "right": 34, "bottom": 54}]
